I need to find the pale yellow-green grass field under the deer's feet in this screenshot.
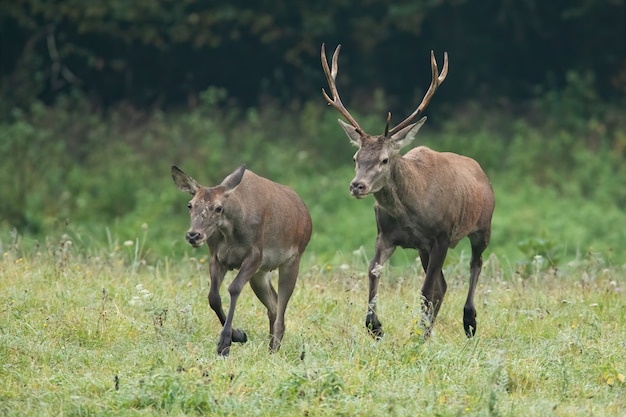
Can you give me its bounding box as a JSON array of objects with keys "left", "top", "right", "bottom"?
[{"left": 0, "top": 232, "right": 626, "bottom": 416}]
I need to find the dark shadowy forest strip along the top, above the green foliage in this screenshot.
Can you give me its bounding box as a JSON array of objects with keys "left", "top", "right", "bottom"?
[{"left": 0, "top": 0, "right": 626, "bottom": 116}]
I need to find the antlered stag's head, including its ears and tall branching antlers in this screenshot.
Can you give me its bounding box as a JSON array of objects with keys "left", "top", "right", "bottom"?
[{"left": 321, "top": 44, "right": 448, "bottom": 198}]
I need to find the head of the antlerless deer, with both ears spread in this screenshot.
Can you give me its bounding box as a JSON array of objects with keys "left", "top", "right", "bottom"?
[{"left": 172, "top": 164, "right": 246, "bottom": 247}]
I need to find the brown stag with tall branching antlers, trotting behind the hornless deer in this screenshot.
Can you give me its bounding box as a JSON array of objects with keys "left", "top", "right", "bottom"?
[{"left": 321, "top": 44, "right": 495, "bottom": 338}]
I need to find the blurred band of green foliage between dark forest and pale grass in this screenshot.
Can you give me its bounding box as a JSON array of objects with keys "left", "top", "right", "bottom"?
[{"left": 0, "top": 83, "right": 626, "bottom": 264}]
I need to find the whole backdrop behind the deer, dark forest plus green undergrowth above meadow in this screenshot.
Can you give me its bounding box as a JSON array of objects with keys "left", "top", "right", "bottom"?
[{"left": 0, "top": 0, "right": 626, "bottom": 268}]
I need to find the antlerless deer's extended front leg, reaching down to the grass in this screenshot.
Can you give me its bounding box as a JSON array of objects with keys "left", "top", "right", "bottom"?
[{"left": 217, "top": 250, "right": 261, "bottom": 356}]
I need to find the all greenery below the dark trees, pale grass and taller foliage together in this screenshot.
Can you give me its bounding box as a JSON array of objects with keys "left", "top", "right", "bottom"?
[{"left": 0, "top": 83, "right": 626, "bottom": 416}]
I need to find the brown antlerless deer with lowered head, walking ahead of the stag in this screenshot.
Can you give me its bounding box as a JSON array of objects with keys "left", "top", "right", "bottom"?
[{"left": 172, "top": 164, "right": 312, "bottom": 356}]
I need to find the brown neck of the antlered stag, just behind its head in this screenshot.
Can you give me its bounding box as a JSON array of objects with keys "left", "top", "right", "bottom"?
[{"left": 374, "top": 157, "right": 425, "bottom": 215}]
